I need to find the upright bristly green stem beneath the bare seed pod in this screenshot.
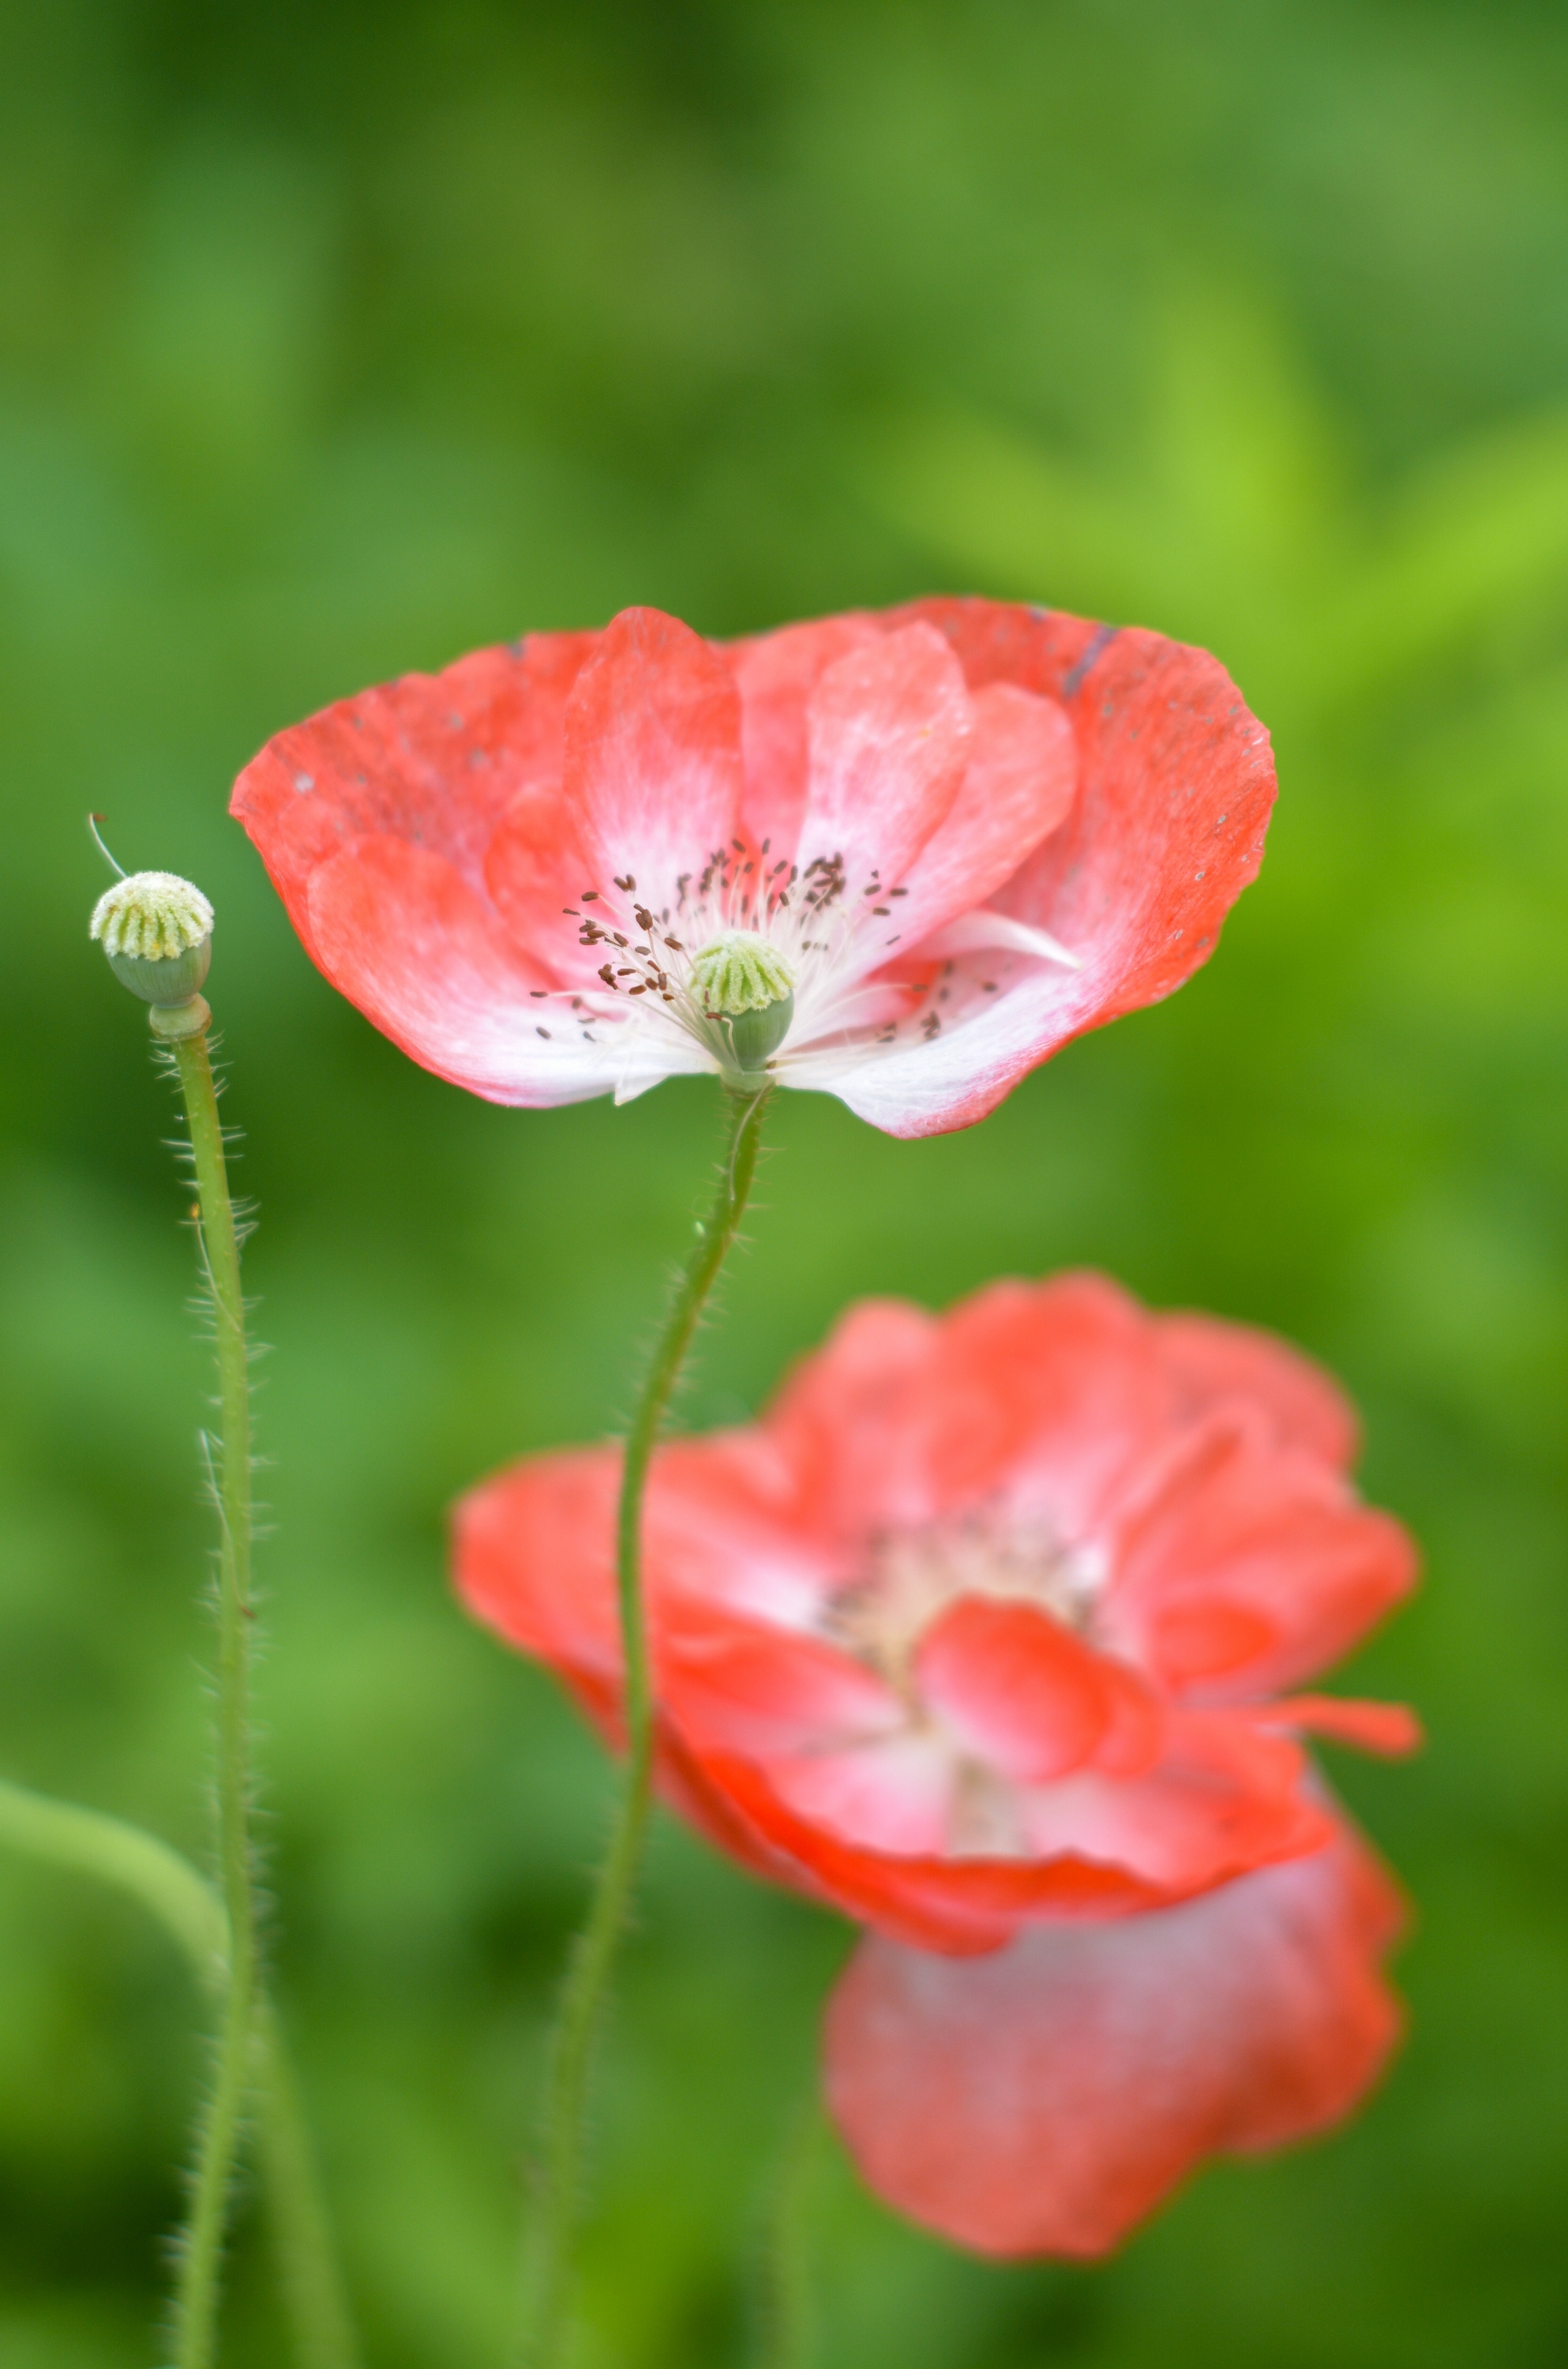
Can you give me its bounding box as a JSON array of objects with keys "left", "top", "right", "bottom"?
[{"left": 167, "top": 1007, "right": 256, "bottom": 2369}]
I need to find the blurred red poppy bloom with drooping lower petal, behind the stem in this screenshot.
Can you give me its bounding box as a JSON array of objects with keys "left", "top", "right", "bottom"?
[{"left": 457, "top": 1275, "right": 1414, "bottom": 2253}]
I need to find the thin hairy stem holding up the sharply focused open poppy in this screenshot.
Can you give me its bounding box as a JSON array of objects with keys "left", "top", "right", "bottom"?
[{"left": 519, "top": 1083, "right": 770, "bottom": 2369}]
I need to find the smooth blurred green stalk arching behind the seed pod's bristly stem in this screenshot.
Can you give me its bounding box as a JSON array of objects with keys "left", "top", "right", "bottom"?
[{"left": 0, "top": 1777, "right": 358, "bottom": 2369}]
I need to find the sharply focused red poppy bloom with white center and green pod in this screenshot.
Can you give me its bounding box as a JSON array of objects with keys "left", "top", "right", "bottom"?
[{"left": 232, "top": 599, "right": 1274, "bottom": 1135}]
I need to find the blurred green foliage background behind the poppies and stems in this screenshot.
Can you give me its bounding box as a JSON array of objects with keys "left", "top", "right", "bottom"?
[{"left": 0, "top": 0, "right": 1568, "bottom": 2369}]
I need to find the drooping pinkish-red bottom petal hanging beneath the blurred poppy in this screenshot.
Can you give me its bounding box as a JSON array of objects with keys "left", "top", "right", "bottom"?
[{"left": 827, "top": 1831, "right": 1400, "bottom": 2258}]
